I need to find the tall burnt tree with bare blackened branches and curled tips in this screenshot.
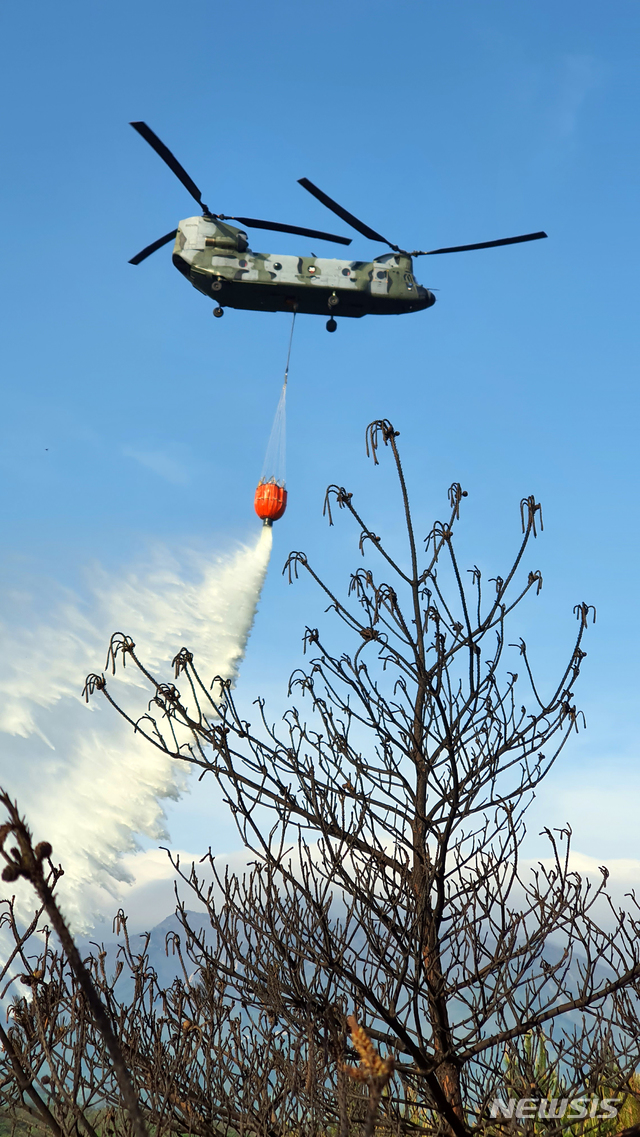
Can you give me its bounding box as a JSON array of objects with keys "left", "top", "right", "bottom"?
[{"left": 1, "top": 421, "right": 640, "bottom": 1137}]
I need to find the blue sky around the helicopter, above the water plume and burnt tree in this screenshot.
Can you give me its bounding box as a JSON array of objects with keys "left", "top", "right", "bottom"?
[{"left": 0, "top": 0, "right": 640, "bottom": 923}]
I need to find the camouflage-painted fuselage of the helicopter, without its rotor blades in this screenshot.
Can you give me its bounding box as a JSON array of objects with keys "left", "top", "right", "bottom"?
[{"left": 173, "top": 216, "right": 435, "bottom": 317}]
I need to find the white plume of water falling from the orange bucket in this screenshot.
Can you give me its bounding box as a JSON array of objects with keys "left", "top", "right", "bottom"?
[{"left": 0, "top": 529, "right": 272, "bottom": 932}]
